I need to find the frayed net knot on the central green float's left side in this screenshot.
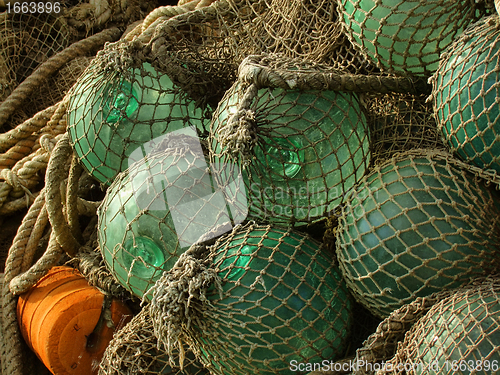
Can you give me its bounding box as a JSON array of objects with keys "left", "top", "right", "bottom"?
[{"left": 219, "top": 109, "right": 257, "bottom": 164}]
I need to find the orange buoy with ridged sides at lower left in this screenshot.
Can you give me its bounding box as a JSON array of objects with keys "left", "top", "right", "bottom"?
[{"left": 17, "top": 266, "right": 132, "bottom": 375}]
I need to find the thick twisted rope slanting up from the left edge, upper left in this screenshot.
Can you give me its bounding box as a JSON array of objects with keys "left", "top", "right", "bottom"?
[{"left": 0, "top": 28, "right": 121, "bottom": 127}]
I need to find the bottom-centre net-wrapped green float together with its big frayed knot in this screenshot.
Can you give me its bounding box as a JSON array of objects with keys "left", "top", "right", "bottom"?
[{"left": 149, "top": 222, "right": 352, "bottom": 374}]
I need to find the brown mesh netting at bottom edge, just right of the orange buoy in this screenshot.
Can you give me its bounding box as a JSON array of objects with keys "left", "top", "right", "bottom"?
[{"left": 99, "top": 307, "right": 208, "bottom": 375}]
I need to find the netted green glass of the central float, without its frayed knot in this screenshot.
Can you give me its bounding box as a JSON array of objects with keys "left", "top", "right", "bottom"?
[{"left": 210, "top": 83, "right": 370, "bottom": 225}]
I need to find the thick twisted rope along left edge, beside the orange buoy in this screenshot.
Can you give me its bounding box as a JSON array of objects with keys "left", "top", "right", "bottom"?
[{"left": 1, "top": 190, "right": 45, "bottom": 375}]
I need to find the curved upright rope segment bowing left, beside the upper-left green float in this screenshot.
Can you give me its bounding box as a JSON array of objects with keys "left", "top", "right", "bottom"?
[{"left": 45, "top": 133, "right": 80, "bottom": 257}]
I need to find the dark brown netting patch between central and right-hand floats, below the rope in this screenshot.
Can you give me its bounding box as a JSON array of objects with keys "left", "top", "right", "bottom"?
[{"left": 366, "top": 94, "right": 445, "bottom": 163}]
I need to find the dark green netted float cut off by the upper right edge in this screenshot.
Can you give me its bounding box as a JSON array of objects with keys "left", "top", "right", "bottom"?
[{"left": 432, "top": 17, "right": 500, "bottom": 172}]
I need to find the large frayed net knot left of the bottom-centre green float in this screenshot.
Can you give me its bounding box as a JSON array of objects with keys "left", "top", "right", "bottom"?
[{"left": 149, "top": 245, "right": 222, "bottom": 368}]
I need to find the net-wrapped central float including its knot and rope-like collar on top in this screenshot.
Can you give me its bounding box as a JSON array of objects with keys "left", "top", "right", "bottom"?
[{"left": 209, "top": 56, "right": 370, "bottom": 228}]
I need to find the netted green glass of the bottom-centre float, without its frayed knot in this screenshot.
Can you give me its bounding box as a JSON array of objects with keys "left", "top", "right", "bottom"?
[{"left": 193, "top": 224, "right": 352, "bottom": 375}]
